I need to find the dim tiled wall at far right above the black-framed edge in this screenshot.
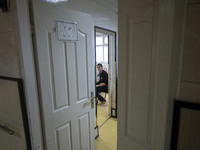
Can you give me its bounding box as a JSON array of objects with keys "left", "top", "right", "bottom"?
[{"left": 180, "top": 0, "right": 200, "bottom": 103}]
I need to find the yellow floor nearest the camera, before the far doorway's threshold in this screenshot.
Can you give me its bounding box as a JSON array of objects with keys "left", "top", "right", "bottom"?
[{"left": 95, "top": 118, "right": 117, "bottom": 150}]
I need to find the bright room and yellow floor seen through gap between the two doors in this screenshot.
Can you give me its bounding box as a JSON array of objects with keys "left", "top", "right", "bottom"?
[{"left": 95, "top": 27, "right": 117, "bottom": 149}]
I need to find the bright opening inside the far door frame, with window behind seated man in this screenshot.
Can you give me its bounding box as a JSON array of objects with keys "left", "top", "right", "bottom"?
[{"left": 95, "top": 28, "right": 110, "bottom": 128}]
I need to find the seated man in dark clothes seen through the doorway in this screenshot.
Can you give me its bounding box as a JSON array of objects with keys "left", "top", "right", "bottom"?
[{"left": 96, "top": 63, "right": 108, "bottom": 102}]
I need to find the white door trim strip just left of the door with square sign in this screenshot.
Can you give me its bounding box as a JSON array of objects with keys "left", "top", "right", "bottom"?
[{"left": 16, "top": 0, "right": 43, "bottom": 150}]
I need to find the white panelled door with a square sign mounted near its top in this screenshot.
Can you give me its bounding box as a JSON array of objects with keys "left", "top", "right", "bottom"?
[{"left": 32, "top": 0, "right": 95, "bottom": 150}]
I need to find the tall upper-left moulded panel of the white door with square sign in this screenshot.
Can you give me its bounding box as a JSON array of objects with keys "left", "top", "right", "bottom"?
[{"left": 48, "top": 30, "right": 69, "bottom": 110}]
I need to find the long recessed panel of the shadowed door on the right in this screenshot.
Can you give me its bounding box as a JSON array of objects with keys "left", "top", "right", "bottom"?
[{"left": 119, "top": 2, "right": 155, "bottom": 150}]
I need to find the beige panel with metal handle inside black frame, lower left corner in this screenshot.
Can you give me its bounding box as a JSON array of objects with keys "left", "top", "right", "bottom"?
[{"left": 0, "top": 77, "right": 30, "bottom": 150}]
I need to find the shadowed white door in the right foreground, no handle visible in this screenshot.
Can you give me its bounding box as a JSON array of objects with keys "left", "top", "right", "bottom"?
[{"left": 118, "top": 0, "right": 184, "bottom": 150}]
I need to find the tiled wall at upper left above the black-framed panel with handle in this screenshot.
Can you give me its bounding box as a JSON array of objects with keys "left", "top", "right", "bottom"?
[{"left": 0, "top": 1, "right": 20, "bottom": 78}]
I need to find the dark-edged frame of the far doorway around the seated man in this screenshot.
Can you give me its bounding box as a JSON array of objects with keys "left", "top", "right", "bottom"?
[{"left": 94, "top": 26, "right": 118, "bottom": 118}]
